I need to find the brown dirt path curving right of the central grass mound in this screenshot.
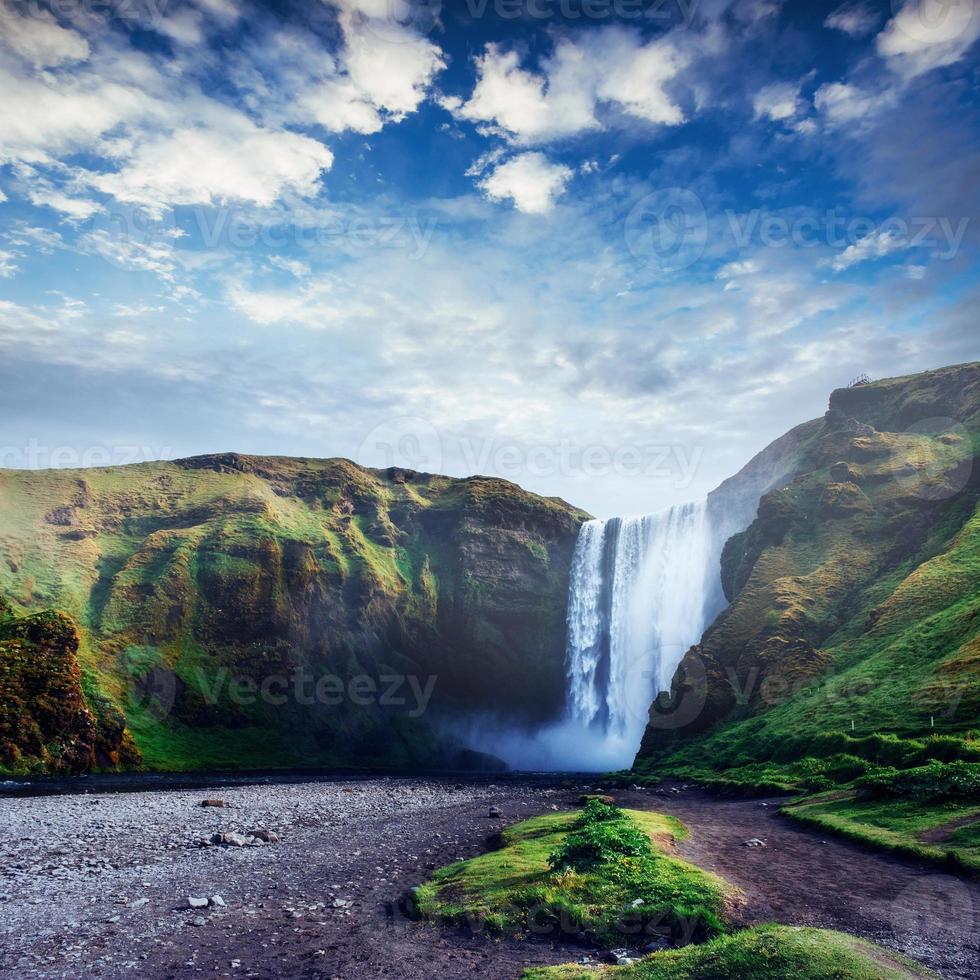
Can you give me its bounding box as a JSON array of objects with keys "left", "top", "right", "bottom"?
[{"left": 620, "top": 789, "right": 980, "bottom": 980}]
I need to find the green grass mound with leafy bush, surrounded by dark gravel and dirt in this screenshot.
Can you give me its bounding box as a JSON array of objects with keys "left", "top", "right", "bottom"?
[{"left": 416, "top": 801, "right": 738, "bottom": 945}]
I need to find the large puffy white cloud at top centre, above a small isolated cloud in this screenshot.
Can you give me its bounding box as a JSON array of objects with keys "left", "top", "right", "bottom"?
[{"left": 443, "top": 27, "right": 688, "bottom": 145}]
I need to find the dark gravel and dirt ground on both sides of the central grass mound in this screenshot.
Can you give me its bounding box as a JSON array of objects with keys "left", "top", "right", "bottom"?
[{"left": 0, "top": 779, "right": 980, "bottom": 980}]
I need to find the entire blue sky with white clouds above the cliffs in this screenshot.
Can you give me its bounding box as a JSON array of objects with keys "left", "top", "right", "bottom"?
[{"left": 0, "top": 0, "right": 980, "bottom": 516}]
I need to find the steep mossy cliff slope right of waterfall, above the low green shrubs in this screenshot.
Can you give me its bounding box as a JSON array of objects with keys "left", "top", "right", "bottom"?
[{"left": 637, "top": 364, "right": 980, "bottom": 768}]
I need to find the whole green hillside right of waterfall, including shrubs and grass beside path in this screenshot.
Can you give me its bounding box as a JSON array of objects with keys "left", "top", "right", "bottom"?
[{"left": 635, "top": 364, "right": 980, "bottom": 867}]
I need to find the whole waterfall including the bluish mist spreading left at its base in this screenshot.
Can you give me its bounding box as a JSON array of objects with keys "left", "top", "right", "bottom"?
[{"left": 463, "top": 503, "right": 730, "bottom": 772}]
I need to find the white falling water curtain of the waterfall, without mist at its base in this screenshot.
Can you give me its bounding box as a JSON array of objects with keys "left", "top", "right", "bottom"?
[{"left": 566, "top": 503, "right": 718, "bottom": 751}]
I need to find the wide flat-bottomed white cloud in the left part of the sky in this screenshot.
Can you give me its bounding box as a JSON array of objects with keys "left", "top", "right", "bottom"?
[{"left": 91, "top": 118, "right": 333, "bottom": 215}]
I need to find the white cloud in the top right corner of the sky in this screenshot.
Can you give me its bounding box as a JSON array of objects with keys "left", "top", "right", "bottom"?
[{"left": 875, "top": 0, "right": 980, "bottom": 78}]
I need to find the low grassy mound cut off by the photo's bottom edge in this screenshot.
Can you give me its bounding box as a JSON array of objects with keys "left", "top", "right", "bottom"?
[{"left": 524, "top": 925, "right": 935, "bottom": 980}]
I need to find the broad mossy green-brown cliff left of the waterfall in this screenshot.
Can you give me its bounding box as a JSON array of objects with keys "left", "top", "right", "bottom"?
[{"left": 0, "top": 454, "right": 586, "bottom": 769}]
